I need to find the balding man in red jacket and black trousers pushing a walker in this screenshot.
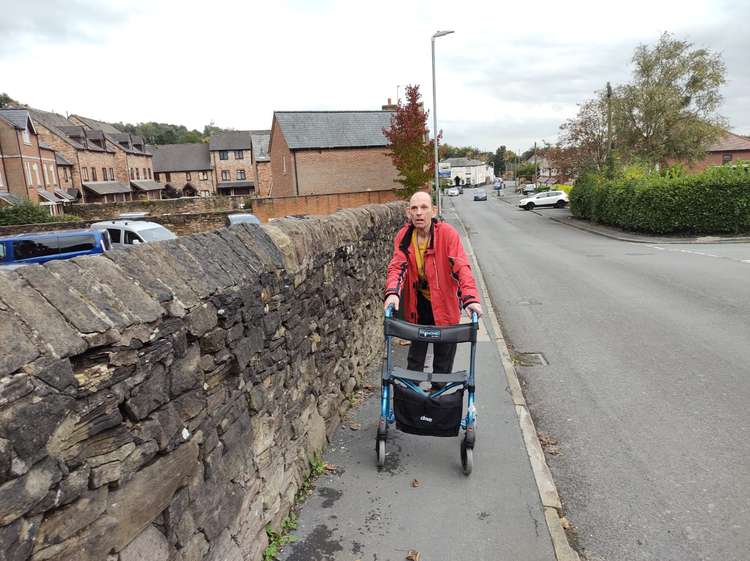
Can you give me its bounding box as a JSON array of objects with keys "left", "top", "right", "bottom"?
[{"left": 384, "top": 191, "right": 482, "bottom": 372}]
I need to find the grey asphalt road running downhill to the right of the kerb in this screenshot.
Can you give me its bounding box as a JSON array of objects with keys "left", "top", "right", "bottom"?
[{"left": 444, "top": 189, "right": 750, "bottom": 561}]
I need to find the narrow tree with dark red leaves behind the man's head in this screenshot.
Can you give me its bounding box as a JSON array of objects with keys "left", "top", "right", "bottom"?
[{"left": 383, "top": 85, "right": 442, "bottom": 199}]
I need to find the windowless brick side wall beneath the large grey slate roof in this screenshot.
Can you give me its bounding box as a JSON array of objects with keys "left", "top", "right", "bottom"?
[{"left": 294, "top": 148, "right": 398, "bottom": 195}]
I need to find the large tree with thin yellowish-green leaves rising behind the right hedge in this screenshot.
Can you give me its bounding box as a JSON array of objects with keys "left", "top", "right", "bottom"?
[{"left": 613, "top": 33, "right": 726, "bottom": 165}]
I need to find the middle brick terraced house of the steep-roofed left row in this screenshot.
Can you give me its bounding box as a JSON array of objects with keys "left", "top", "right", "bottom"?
[{"left": 28, "top": 108, "right": 133, "bottom": 203}]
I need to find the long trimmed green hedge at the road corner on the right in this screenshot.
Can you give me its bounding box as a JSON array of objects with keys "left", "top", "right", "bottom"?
[{"left": 570, "top": 165, "right": 750, "bottom": 234}]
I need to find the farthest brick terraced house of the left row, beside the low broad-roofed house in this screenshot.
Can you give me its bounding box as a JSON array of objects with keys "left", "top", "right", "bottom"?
[{"left": 68, "top": 115, "right": 164, "bottom": 200}]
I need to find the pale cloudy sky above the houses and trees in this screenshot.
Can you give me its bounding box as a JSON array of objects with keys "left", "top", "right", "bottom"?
[{"left": 0, "top": 0, "right": 750, "bottom": 151}]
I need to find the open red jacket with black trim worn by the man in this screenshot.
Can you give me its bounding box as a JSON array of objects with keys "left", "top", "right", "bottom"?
[{"left": 385, "top": 219, "right": 479, "bottom": 325}]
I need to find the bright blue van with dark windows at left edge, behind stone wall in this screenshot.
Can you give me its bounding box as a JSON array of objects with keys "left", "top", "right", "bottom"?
[{"left": 0, "top": 230, "right": 111, "bottom": 269}]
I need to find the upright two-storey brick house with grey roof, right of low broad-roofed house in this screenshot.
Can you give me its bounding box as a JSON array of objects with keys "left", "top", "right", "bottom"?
[{"left": 208, "top": 131, "right": 256, "bottom": 195}]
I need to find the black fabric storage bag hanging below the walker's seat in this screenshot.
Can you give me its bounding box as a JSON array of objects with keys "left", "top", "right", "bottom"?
[{"left": 393, "top": 384, "right": 464, "bottom": 436}]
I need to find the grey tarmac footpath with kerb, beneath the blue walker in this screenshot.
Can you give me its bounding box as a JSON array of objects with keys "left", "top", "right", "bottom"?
[{"left": 279, "top": 211, "right": 578, "bottom": 561}]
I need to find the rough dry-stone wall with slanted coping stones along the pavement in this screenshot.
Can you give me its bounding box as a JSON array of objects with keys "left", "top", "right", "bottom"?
[{"left": 0, "top": 204, "right": 403, "bottom": 561}]
